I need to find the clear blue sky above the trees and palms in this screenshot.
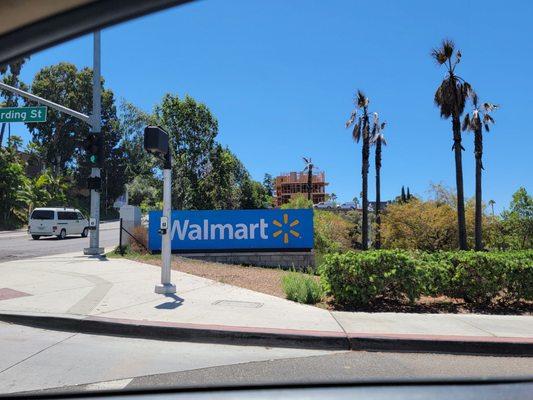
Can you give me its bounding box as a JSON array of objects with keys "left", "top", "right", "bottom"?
[{"left": 8, "top": 0, "right": 533, "bottom": 210}]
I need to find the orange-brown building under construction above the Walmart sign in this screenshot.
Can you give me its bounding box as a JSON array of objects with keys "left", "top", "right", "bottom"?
[{"left": 276, "top": 172, "right": 328, "bottom": 207}]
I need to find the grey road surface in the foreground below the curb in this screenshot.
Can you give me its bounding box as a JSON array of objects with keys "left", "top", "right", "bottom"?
[{"left": 0, "top": 323, "right": 533, "bottom": 394}]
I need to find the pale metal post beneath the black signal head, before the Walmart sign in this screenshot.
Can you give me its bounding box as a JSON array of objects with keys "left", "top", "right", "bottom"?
[{"left": 155, "top": 150, "right": 176, "bottom": 294}]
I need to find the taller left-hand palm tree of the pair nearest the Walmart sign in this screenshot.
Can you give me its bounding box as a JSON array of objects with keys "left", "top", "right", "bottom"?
[{"left": 346, "top": 90, "right": 370, "bottom": 250}]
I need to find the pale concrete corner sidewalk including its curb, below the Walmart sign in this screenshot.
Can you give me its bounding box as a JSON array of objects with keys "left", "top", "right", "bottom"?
[{"left": 0, "top": 254, "right": 533, "bottom": 355}]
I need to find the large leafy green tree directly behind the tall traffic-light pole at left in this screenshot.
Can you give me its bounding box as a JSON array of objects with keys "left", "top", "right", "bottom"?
[{"left": 26, "top": 62, "right": 121, "bottom": 209}]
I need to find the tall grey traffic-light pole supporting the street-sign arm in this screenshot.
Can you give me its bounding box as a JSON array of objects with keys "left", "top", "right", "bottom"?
[{"left": 84, "top": 31, "right": 104, "bottom": 255}]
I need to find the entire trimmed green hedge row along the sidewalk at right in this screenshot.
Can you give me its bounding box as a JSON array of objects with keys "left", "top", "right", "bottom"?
[{"left": 319, "top": 250, "right": 533, "bottom": 306}]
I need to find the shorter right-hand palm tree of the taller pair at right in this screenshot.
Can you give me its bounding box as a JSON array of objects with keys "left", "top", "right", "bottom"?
[{"left": 463, "top": 94, "right": 498, "bottom": 251}]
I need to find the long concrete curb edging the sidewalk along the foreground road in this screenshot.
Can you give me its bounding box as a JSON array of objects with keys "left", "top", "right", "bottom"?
[{"left": 0, "top": 313, "right": 533, "bottom": 357}]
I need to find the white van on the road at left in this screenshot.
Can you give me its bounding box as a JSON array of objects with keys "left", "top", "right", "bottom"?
[{"left": 28, "top": 207, "right": 89, "bottom": 240}]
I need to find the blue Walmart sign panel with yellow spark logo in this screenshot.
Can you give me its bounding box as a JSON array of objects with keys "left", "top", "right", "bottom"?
[{"left": 148, "top": 209, "right": 313, "bottom": 251}]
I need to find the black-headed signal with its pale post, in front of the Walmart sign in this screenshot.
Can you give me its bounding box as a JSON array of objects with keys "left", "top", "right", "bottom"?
[{"left": 144, "top": 126, "right": 176, "bottom": 294}]
